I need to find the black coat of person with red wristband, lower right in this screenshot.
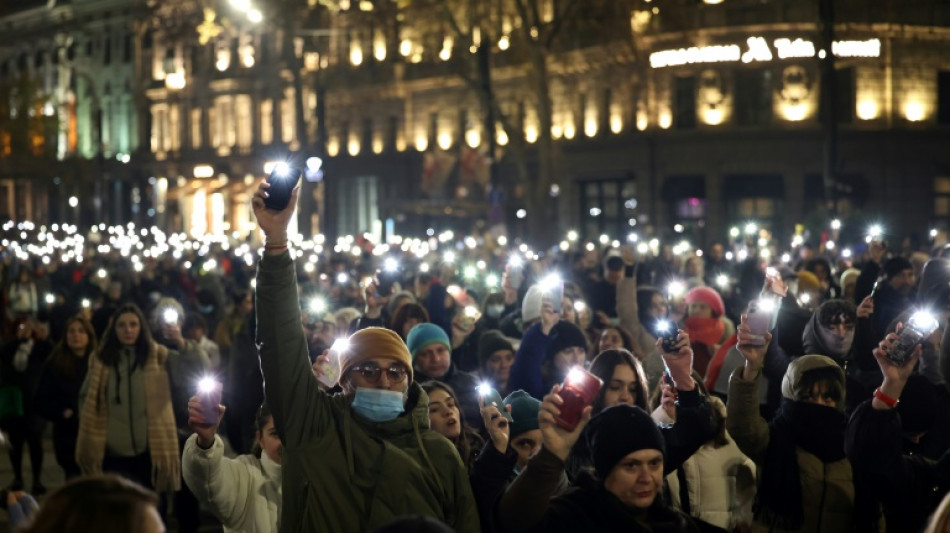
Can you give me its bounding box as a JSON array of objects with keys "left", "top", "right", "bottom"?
[{"left": 845, "top": 400, "right": 950, "bottom": 533}]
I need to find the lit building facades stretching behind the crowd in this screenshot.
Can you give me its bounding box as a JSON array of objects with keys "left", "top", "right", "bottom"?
[{"left": 0, "top": 0, "right": 950, "bottom": 248}]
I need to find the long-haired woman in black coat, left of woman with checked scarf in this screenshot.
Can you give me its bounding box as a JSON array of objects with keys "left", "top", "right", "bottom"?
[{"left": 36, "top": 315, "right": 96, "bottom": 480}]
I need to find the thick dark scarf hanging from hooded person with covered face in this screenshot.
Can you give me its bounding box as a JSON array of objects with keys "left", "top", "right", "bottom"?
[{"left": 754, "top": 398, "right": 848, "bottom": 530}]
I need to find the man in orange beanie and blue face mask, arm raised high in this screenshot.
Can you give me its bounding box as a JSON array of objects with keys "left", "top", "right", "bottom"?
[{"left": 252, "top": 183, "right": 480, "bottom": 533}]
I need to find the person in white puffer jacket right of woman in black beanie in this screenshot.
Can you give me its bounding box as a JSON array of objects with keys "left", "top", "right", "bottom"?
[{"left": 652, "top": 380, "right": 756, "bottom": 531}]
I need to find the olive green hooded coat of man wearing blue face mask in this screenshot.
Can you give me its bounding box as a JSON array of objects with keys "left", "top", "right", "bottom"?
[{"left": 257, "top": 253, "right": 479, "bottom": 532}]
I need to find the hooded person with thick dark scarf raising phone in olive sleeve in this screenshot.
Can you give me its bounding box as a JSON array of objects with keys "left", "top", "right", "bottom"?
[{"left": 726, "top": 314, "right": 875, "bottom": 532}]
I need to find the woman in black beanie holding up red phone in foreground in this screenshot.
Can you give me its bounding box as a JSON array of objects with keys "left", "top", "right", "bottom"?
[{"left": 497, "top": 402, "right": 699, "bottom": 532}]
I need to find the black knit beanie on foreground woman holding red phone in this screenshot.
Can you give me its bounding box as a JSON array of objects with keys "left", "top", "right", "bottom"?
[{"left": 587, "top": 404, "right": 666, "bottom": 482}]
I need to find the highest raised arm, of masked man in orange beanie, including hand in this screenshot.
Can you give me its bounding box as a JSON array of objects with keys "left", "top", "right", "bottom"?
[{"left": 252, "top": 182, "right": 330, "bottom": 448}]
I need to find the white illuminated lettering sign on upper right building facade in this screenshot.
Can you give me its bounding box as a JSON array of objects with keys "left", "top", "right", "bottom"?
[{"left": 650, "top": 37, "right": 881, "bottom": 68}]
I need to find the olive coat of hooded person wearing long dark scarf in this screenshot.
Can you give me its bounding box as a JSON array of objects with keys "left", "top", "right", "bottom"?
[{"left": 726, "top": 367, "right": 854, "bottom": 533}]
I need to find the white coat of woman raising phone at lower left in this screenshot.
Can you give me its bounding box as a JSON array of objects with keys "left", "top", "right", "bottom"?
[{"left": 181, "top": 435, "right": 281, "bottom": 533}]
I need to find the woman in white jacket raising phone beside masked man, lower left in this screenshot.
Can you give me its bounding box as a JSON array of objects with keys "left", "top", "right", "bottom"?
[{"left": 181, "top": 396, "right": 283, "bottom": 533}]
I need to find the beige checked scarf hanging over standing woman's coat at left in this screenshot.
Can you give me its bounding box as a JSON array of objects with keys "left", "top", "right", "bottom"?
[{"left": 76, "top": 342, "right": 181, "bottom": 492}]
